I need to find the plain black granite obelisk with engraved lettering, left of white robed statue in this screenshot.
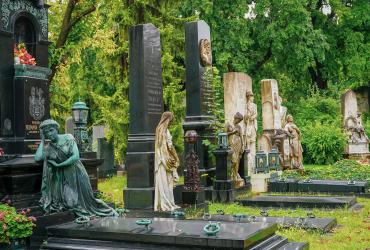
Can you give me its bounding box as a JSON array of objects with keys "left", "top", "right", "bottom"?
[{"left": 123, "top": 24, "right": 163, "bottom": 209}]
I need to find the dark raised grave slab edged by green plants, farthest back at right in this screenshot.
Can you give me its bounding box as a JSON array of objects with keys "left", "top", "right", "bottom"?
[{"left": 269, "top": 179, "right": 369, "bottom": 194}]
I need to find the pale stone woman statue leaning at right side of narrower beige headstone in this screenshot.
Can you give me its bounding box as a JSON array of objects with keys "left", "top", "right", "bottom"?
[{"left": 284, "top": 115, "right": 303, "bottom": 170}]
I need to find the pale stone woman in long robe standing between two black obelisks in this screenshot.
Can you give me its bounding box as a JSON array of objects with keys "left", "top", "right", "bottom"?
[{"left": 154, "top": 111, "right": 180, "bottom": 211}]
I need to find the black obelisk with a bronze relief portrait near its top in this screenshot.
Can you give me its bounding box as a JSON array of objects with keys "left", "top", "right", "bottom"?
[{"left": 183, "top": 20, "right": 214, "bottom": 186}]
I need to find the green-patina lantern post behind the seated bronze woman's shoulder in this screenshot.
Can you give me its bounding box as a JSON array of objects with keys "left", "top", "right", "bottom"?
[{"left": 72, "top": 101, "right": 90, "bottom": 152}]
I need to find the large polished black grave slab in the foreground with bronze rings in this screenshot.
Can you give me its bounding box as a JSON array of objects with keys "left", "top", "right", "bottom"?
[{"left": 48, "top": 218, "right": 277, "bottom": 249}]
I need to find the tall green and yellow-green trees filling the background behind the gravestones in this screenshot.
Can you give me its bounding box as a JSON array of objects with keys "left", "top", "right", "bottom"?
[{"left": 49, "top": 0, "right": 370, "bottom": 162}]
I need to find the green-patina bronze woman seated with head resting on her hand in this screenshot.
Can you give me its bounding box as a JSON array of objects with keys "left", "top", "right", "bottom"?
[{"left": 35, "top": 119, "right": 117, "bottom": 217}]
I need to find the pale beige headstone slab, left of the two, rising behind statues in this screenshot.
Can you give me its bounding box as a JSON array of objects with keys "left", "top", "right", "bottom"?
[{"left": 224, "top": 72, "right": 252, "bottom": 131}]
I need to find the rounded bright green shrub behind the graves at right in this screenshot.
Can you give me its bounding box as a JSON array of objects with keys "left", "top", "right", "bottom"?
[{"left": 302, "top": 123, "right": 346, "bottom": 164}]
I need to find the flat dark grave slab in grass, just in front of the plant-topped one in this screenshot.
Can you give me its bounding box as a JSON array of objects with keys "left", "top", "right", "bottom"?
[{"left": 238, "top": 195, "right": 356, "bottom": 208}]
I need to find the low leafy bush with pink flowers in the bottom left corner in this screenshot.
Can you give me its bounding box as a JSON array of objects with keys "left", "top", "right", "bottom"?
[{"left": 0, "top": 204, "right": 36, "bottom": 244}]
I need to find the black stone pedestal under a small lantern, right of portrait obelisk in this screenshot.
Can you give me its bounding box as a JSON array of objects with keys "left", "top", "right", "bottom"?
[{"left": 212, "top": 149, "right": 235, "bottom": 203}]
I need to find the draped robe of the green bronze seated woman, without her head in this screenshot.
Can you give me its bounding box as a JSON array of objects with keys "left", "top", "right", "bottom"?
[{"left": 40, "top": 134, "right": 117, "bottom": 217}]
